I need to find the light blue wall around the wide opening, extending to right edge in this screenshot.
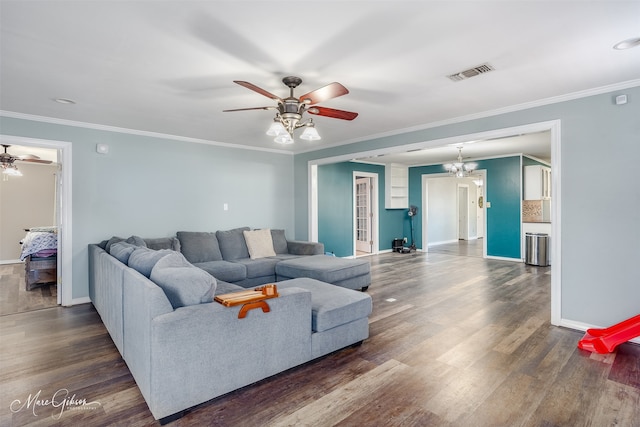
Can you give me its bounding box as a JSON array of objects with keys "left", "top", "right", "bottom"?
[{"left": 294, "top": 86, "right": 640, "bottom": 326}]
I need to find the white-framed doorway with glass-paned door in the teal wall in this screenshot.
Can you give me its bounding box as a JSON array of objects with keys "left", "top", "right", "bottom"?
[{"left": 353, "top": 172, "right": 378, "bottom": 257}]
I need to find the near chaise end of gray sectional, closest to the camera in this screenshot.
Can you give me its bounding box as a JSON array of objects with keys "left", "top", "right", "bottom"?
[{"left": 278, "top": 280, "right": 373, "bottom": 358}]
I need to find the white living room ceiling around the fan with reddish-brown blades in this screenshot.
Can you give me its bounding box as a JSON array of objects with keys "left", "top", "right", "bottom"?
[{"left": 0, "top": 0, "right": 640, "bottom": 163}]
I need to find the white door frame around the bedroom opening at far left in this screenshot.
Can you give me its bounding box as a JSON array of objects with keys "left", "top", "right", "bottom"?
[{"left": 0, "top": 134, "right": 73, "bottom": 306}]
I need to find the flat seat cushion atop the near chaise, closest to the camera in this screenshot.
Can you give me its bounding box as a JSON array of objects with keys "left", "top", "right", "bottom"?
[{"left": 278, "top": 278, "right": 373, "bottom": 332}]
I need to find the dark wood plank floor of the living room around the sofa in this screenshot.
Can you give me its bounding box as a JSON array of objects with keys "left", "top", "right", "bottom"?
[{"left": 0, "top": 247, "right": 640, "bottom": 427}]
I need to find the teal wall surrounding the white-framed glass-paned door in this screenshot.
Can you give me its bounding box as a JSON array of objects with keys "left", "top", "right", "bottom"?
[{"left": 318, "top": 162, "right": 407, "bottom": 257}]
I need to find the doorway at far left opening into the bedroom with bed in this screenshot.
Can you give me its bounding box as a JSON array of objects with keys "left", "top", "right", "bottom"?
[{"left": 0, "top": 135, "right": 72, "bottom": 315}]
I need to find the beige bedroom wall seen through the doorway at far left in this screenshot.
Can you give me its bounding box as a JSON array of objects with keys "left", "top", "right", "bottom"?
[{"left": 0, "top": 162, "right": 57, "bottom": 261}]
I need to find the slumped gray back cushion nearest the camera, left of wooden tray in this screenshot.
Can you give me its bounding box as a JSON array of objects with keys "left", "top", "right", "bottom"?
[{"left": 150, "top": 252, "right": 217, "bottom": 309}]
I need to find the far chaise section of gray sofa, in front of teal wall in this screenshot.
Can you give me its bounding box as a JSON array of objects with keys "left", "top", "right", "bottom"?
[{"left": 276, "top": 255, "right": 371, "bottom": 291}]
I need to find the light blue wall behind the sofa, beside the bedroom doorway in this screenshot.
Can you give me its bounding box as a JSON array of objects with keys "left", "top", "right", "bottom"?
[{"left": 0, "top": 117, "right": 294, "bottom": 299}]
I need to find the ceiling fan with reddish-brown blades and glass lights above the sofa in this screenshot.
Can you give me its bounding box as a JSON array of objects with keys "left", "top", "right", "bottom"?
[{"left": 223, "top": 76, "right": 358, "bottom": 144}]
